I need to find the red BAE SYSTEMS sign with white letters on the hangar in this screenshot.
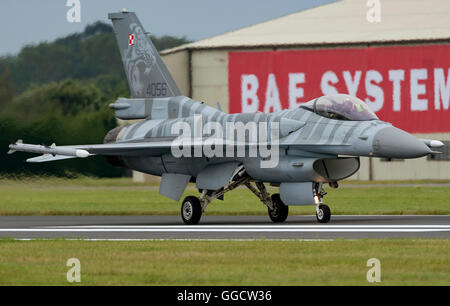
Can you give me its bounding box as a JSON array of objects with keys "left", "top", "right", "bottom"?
[{"left": 228, "top": 44, "right": 450, "bottom": 133}]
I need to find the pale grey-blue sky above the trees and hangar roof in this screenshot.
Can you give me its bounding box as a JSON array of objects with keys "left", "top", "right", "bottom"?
[{"left": 0, "top": 0, "right": 335, "bottom": 56}]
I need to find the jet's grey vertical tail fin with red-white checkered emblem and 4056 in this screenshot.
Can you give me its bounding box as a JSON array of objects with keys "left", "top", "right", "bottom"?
[{"left": 108, "top": 11, "right": 181, "bottom": 98}]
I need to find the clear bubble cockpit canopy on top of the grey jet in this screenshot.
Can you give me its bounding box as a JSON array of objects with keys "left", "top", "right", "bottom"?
[{"left": 302, "top": 94, "right": 378, "bottom": 121}]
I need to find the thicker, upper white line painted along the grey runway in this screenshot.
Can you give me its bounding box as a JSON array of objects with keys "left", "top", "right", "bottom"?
[{"left": 0, "top": 224, "right": 450, "bottom": 233}]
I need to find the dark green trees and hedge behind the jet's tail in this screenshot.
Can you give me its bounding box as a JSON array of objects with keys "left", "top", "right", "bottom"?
[{"left": 0, "top": 22, "right": 189, "bottom": 177}]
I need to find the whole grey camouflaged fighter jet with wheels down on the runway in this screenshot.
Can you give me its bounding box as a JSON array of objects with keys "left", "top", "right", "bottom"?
[{"left": 8, "top": 10, "right": 443, "bottom": 224}]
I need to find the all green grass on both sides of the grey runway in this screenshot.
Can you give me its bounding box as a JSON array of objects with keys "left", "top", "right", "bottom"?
[{"left": 0, "top": 178, "right": 450, "bottom": 285}]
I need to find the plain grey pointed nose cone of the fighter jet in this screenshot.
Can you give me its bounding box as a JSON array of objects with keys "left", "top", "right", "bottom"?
[{"left": 373, "top": 127, "right": 431, "bottom": 158}]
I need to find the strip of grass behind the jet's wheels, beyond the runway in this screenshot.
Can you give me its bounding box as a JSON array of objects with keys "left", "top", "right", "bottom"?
[{"left": 0, "top": 178, "right": 450, "bottom": 215}]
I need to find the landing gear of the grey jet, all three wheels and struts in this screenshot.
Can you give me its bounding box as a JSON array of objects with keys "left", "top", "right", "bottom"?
[{"left": 181, "top": 170, "right": 331, "bottom": 225}]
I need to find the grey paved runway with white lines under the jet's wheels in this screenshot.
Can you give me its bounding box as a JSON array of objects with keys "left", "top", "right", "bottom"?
[{"left": 0, "top": 215, "right": 450, "bottom": 239}]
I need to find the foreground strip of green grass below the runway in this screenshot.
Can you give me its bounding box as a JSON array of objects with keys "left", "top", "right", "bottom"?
[{"left": 0, "top": 239, "right": 450, "bottom": 285}]
